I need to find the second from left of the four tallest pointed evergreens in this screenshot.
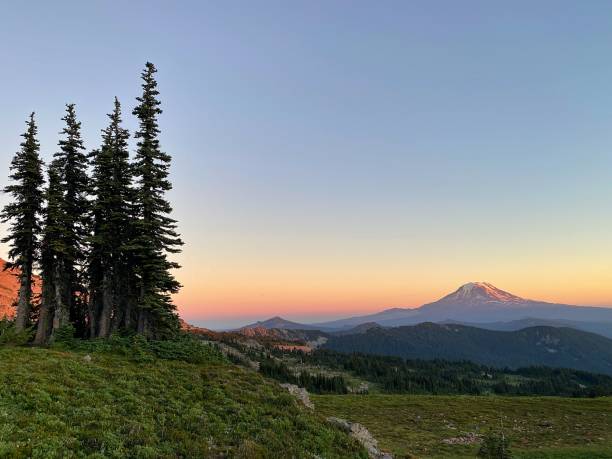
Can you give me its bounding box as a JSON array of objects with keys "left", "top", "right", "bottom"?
[{"left": 53, "top": 104, "right": 89, "bottom": 335}]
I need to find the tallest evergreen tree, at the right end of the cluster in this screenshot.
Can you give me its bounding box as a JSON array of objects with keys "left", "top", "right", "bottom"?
[{"left": 133, "top": 62, "right": 182, "bottom": 336}]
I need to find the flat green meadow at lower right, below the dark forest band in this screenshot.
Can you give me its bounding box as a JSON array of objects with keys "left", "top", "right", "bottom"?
[{"left": 312, "top": 394, "right": 612, "bottom": 459}]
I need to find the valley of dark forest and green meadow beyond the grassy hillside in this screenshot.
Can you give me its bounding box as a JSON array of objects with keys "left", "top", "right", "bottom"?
[{"left": 184, "top": 329, "right": 612, "bottom": 459}]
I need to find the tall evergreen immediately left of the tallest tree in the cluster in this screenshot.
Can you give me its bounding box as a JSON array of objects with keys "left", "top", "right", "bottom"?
[{"left": 89, "top": 98, "right": 131, "bottom": 337}]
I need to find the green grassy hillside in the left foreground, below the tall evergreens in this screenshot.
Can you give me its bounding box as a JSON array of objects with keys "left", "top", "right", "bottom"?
[{"left": 0, "top": 346, "right": 367, "bottom": 459}]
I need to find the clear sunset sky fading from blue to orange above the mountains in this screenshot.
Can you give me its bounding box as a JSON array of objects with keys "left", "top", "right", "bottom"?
[{"left": 0, "top": 0, "right": 612, "bottom": 328}]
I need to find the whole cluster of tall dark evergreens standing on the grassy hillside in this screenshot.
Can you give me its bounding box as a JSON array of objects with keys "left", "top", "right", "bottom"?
[{"left": 0, "top": 63, "right": 182, "bottom": 344}]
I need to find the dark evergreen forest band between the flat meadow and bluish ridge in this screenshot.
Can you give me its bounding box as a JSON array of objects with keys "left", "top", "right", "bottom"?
[{"left": 260, "top": 349, "right": 612, "bottom": 397}]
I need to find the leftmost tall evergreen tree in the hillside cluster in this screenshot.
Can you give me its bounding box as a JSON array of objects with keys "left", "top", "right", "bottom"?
[{"left": 0, "top": 113, "right": 44, "bottom": 331}]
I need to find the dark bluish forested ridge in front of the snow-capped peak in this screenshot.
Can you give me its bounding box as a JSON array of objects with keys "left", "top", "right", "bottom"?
[{"left": 324, "top": 323, "right": 612, "bottom": 374}]
